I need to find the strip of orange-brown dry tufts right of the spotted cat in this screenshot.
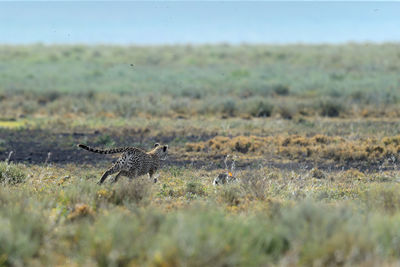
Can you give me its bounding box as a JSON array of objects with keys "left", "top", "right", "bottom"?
[{"left": 185, "top": 134, "right": 400, "bottom": 168}]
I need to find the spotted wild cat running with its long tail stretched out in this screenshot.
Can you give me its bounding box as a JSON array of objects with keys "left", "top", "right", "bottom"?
[{"left": 78, "top": 143, "right": 168, "bottom": 184}]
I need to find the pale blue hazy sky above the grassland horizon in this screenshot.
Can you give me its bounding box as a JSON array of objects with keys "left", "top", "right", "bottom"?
[{"left": 0, "top": 1, "right": 400, "bottom": 44}]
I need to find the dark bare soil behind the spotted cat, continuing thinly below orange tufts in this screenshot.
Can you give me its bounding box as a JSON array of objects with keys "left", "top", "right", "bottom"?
[{"left": 0, "top": 129, "right": 396, "bottom": 172}]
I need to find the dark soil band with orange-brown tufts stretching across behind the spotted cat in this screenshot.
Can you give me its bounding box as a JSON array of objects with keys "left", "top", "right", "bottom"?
[{"left": 0, "top": 129, "right": 400, "bottom": 172}]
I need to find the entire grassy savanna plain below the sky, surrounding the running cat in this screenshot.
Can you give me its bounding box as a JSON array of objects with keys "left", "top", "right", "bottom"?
[{"left": 0, "top": 43, "right": 400, "bottom": 266}]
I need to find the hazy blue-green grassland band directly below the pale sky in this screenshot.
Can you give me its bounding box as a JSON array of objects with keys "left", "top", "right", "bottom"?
[{"left": 0, "top": 44, "right": 400, "bottom": 118}]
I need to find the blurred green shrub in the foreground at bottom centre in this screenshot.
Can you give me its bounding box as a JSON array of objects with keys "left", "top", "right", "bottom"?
[{"left": 151, "top": 207, "right": 290, "bottom": 267}]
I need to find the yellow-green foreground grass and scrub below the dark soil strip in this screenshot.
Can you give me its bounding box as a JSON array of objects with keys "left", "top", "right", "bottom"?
[{"left": 0, "top": 165, "right": 400, "bottom": 266}]
